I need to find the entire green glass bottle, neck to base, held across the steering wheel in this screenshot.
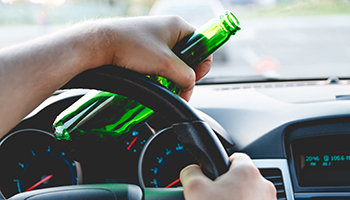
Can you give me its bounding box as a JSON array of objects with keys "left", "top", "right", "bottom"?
[{"left": 53, "top": 11, "right": 240, "bottom": 160}]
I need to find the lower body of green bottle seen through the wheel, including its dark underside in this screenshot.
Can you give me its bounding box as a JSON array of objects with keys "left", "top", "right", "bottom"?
[{"left": 53, "top": 90, "right": 154, "bottom": 161}]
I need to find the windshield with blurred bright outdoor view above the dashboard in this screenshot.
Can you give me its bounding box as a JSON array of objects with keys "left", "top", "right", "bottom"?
[{"left": 0, "top": 0, "right": 350, "bottom": 83}]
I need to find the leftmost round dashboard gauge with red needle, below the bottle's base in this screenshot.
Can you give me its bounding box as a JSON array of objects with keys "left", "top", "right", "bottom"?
[{"left": 0, "top": 129, "right": 81, "bottom": 198}]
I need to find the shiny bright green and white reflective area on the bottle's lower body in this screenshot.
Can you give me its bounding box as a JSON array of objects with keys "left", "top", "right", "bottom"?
[{"left": 54, "top": 91, "right": 154, "bottom": 140}]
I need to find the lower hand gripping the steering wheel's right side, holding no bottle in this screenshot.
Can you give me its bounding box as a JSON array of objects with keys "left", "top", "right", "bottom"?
[{"left": 180, "top": 153, "right": 276, "bottom": 200}]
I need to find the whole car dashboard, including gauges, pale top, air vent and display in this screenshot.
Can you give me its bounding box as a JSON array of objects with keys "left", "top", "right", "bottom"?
[{"left": 0, "top": 80, "right": 350, "bottom": 200}]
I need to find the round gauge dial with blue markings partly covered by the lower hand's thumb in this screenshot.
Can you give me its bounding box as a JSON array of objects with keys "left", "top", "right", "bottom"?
[{"left": 139, "top": 129, "right": 197, "bottom": 188}]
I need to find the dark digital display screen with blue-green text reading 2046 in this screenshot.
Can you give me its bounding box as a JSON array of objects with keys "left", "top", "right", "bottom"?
[{"left": 292, "top": 135, "right": 350, "bottom": 187}]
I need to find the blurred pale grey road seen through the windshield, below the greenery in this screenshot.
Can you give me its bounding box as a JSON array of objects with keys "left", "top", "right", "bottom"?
[{"left": 0, "top": 15, "right": 350, "bottom": 78}]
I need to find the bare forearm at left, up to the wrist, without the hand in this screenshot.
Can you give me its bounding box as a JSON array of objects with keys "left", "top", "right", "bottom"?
[{"left": 0, "top": 22, "right": 106, "bottom": 137}]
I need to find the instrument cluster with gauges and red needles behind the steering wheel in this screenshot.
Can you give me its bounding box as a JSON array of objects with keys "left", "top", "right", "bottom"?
[{"left": 0, "top": 92, "right": 224, "bottom": 198}]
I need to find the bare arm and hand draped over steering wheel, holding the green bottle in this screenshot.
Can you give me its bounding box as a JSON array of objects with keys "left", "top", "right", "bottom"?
[{"left": 0, "top": 17, "right": 211, "bottom": 138}]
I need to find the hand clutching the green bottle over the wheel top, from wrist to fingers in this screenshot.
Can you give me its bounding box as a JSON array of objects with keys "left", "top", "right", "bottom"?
[{"left": 93, "top": 16, "right": 212, "bottom": 101}]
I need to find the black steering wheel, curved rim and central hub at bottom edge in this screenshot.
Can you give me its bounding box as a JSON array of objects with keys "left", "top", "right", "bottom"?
[{"left": 11, "top": 65, "right": 229, "bottom": 200}]
